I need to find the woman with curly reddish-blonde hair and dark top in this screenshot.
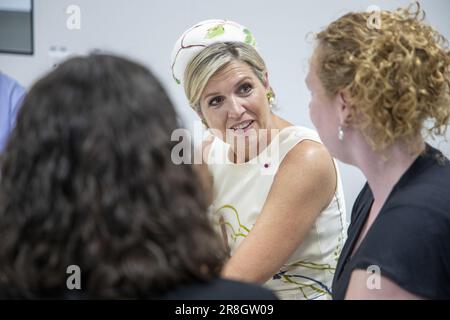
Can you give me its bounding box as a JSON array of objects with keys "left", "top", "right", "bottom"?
[{"left": 306, "top": 2, "right": 450, "bottom": 299}]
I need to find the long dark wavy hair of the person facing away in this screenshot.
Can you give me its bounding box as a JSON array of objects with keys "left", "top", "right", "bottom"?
[{"left": 0, "top": 54, "right": 224, "bottom": 299}]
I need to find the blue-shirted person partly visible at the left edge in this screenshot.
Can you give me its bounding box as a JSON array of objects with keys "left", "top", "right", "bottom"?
[{"left": 0, "top": 71, "right": 25, "bottom": 152}]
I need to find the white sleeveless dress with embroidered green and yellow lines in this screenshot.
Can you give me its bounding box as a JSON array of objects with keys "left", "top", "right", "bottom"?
[{"left": 207, "top": 126, "right": 347, "bottom": 299}]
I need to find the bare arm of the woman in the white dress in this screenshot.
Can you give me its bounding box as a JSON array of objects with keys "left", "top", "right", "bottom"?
[{"left": 222, "top": 140, "right": 336, "bottom": 283}]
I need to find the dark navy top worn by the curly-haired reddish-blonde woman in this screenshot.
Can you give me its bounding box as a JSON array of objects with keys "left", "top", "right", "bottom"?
[{"left": 333, "top": 145, "right": 450, "bottom": 299}]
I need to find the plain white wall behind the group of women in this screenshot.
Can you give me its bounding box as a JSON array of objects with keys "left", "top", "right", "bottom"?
[{"left": 0, "top": 0, "right": 450, "bottom": 212}]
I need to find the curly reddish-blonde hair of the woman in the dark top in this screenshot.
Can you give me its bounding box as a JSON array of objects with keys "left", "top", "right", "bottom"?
[{"left": 315, "top": 2, "right": 450, "bottom": 150}]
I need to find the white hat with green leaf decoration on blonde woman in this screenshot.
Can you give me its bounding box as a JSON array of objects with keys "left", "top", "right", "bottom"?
[{"left": 172, "top": 19, "right": 257, "bottom": 85}]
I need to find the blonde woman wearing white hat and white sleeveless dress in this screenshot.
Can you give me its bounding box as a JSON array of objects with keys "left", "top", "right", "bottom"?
[{"left": 172, "top": 20, "right": 346, "bottom": 299}]
